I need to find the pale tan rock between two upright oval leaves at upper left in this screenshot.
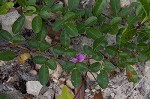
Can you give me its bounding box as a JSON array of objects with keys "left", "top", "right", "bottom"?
[{"left": 24, "top": 14, "right": 37, "bottom": 29}]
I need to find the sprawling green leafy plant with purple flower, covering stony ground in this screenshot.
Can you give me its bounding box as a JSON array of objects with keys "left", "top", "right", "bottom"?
[{"left": 0, "top": 0, "right": 150, "bottom": 89}]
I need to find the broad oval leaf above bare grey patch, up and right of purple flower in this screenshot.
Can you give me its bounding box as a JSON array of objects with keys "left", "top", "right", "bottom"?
[{"left": 86, "top": 27, "right": 102, "bottom": 40}]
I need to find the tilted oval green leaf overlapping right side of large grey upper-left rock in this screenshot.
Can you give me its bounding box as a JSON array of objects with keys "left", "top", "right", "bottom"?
[{"left": 12, "top": 15, "right": 25, "bottom": 34}]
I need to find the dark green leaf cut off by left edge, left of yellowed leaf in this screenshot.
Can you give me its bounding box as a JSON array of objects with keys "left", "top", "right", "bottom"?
[{"left": 0, "top": 51, "right": 17, "bottom": 61}]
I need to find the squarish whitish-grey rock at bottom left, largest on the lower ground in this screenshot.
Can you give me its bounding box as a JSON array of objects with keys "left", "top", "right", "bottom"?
[{"left": 26, "top": 81, "right": 42, "bottom": 96}]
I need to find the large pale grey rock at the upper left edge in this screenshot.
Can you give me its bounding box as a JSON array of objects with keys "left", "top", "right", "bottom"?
[{"left": 0, "top": 10, "right": 20, "bottom": 34}]
